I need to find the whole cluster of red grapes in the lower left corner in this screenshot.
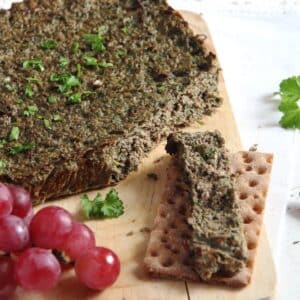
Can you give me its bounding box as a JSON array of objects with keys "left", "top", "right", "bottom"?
[{"left": 0, "top": 183, "right": 120, "bottom": 300}]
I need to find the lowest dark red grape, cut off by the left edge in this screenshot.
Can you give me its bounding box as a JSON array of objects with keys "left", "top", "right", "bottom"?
[{"left": 0, "top": 256, "right": 17, "bottom": 300}]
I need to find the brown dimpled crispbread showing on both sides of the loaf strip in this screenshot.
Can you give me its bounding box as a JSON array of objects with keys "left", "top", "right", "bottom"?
[{"left": 144, "top": 151, "right": 273, "bottom": 287}]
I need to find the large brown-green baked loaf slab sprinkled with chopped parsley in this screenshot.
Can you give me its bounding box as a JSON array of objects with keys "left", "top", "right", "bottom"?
[{"left": 0, "top": 0, "right": 221, "bottom": 203}]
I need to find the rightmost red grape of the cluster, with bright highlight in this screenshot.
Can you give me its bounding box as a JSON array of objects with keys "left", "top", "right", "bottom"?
[{"left": 75, "top": 247, "right": 120, "bottom": 290}]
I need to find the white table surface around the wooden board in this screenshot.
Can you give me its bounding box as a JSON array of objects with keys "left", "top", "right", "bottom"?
[{"left": 0, "top": 0, "right": 300, "bottom": 300}]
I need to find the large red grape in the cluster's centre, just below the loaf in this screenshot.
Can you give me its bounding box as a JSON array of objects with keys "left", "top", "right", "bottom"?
[{"left": 29, "top": 206, "right": 73, "bottom": 249}]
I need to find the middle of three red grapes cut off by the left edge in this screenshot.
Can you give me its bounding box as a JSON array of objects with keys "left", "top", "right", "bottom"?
[{"left": 0, "top": 215, "right": 29, "bottom": 252}]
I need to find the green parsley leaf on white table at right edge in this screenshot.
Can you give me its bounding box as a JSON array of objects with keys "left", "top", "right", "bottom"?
[{"left": 279, "top": 76, "right": 300, "bottom": 129}]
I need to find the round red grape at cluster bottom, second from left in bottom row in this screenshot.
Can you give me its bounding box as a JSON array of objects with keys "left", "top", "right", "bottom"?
[{"left": 15, "top": 248, "right": 61, "bottom": 292}]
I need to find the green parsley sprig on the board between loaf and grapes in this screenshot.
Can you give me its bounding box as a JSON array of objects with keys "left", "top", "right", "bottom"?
[{"left": 80, "top": 189, "right": 124, "bottom": 219}]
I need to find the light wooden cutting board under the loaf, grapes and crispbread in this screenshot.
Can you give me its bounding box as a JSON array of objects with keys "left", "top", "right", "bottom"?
[{"left": 14, "top": 12, "right": 276, "bottom": 300}]
